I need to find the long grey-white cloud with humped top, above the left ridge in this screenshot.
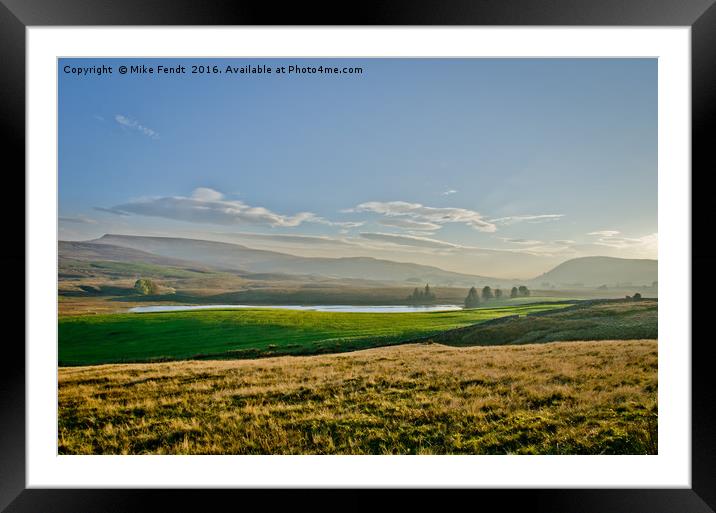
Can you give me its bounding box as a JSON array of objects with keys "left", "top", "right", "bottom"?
[{"left": 95, "top": 187, "right": 363, "bottom": 228}]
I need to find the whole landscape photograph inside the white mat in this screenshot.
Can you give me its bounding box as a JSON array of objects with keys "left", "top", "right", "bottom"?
[{"left": 57, "top": 58, "right": 658, "bottom": 455}]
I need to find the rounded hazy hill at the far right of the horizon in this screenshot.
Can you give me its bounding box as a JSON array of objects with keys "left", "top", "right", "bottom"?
[{"left": 531, "top": 257, "right": 659, "bottom": 288}]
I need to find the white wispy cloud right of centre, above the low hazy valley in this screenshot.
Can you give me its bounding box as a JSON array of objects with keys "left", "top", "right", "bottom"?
[{"left": 344, "top": 201, "right": 497, "bottom": 232}]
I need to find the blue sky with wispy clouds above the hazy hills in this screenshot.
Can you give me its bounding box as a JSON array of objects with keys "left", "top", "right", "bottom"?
[{"left": 59, "top": 59, "right": 658, "bottom": 277}]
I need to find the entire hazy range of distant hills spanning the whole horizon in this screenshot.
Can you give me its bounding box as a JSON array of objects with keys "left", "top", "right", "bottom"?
[{"left": 59, "top": 234, "right": 658, "bottom": 288}]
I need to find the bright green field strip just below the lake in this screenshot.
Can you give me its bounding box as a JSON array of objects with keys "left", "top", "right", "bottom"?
[{"left": 58, "top": 302, "right": 570, "bottom": 366}]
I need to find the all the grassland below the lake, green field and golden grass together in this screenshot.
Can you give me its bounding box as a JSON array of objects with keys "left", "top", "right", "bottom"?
[{"left": 58, "top": 299, "right": 658, "bottom": 454}]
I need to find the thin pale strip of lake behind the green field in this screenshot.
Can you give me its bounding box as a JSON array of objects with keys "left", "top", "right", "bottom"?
[{"left": 129, "top": 305, "right": 462, "bottom": 313}]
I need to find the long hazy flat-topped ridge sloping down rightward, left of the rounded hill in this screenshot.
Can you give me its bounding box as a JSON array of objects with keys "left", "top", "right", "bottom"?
[{"left": 89, "top": 235, "right": 504, "bottom": 287}]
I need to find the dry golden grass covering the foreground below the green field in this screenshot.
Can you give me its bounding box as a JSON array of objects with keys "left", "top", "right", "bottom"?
[{"left": 58, "top": 340, "right": 657, "bottom": 454}]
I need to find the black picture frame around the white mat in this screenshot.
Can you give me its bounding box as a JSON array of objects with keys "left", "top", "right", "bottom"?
[{"left": 0, "top": 0, "right": 716, "bottom": 513}]
